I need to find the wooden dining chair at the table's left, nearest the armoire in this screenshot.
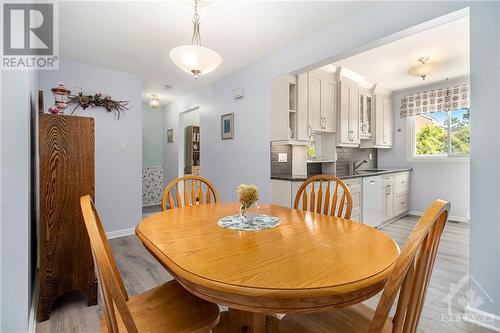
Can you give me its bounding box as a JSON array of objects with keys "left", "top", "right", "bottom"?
[{"left": 80, "top": 195, "right": 219, "bottom": 333}]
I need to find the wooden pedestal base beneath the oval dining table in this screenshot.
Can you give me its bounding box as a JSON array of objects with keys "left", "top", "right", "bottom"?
[{"left": 212, "top": 308, "right": 277, "bottom": 333}]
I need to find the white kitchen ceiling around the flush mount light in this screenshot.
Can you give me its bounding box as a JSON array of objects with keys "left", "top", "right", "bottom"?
[{"left": 333, "top": 17, "right": 469, "bottom": 91}]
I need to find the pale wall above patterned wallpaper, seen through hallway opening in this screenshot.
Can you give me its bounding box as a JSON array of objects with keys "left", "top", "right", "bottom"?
[{"left": 142, "top": 103, "right": 167, "bottom": 167}]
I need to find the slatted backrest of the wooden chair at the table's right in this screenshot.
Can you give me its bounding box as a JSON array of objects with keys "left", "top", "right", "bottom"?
[{"left": 368, "top": 200, "right": 450, "bottom": 333}]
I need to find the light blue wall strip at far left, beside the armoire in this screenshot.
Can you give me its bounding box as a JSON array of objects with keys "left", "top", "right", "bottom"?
[{"left": 0, "top": 71, "right": 37, "bottom": 333}]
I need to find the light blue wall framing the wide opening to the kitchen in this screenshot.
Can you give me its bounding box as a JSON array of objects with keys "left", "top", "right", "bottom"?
[{"left": 164, "top": 1, "right": 500, "bottom": 322}]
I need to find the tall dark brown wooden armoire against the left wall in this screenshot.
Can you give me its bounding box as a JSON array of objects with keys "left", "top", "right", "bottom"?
[{"left": 37, "top": 114, "right": 97, "bottom": 321}]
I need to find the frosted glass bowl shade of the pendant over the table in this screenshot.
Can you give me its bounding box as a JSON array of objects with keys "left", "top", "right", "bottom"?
[{"left": 169, "top": 45, "right": 222, "bottom": 78}]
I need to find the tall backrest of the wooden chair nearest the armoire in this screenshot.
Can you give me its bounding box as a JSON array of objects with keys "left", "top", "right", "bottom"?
[{"left": 80, "top": 195, "right": 138, "bottom": 333}]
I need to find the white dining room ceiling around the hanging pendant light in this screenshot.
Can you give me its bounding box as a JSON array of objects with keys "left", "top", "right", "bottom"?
[{"left": 59, "top": 0, "right": 369, "bottom": 104}]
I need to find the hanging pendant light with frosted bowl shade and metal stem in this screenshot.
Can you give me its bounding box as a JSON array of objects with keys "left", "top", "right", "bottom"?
[{"left": 169, "top": 0, "right": 222, "bottom": 79}]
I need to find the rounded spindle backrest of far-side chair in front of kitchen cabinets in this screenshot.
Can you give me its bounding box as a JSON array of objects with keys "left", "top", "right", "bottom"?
[{"left": 293, "top": 175, "right": 352, "bottom": 219}]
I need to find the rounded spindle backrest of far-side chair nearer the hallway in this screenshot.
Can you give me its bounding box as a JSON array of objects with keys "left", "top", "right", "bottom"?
[{"left": 161, "top": 175, "right": 219, "bottom": 210}]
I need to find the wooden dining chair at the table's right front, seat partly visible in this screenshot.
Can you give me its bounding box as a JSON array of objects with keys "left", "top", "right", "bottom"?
[{"left": 279, "top": 200, "right": 450, "bottom": 333}]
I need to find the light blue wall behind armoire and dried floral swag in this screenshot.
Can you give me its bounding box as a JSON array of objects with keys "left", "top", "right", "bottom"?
[{"left": 40, "top": 59, "right": 142, "bottom": 232}]
